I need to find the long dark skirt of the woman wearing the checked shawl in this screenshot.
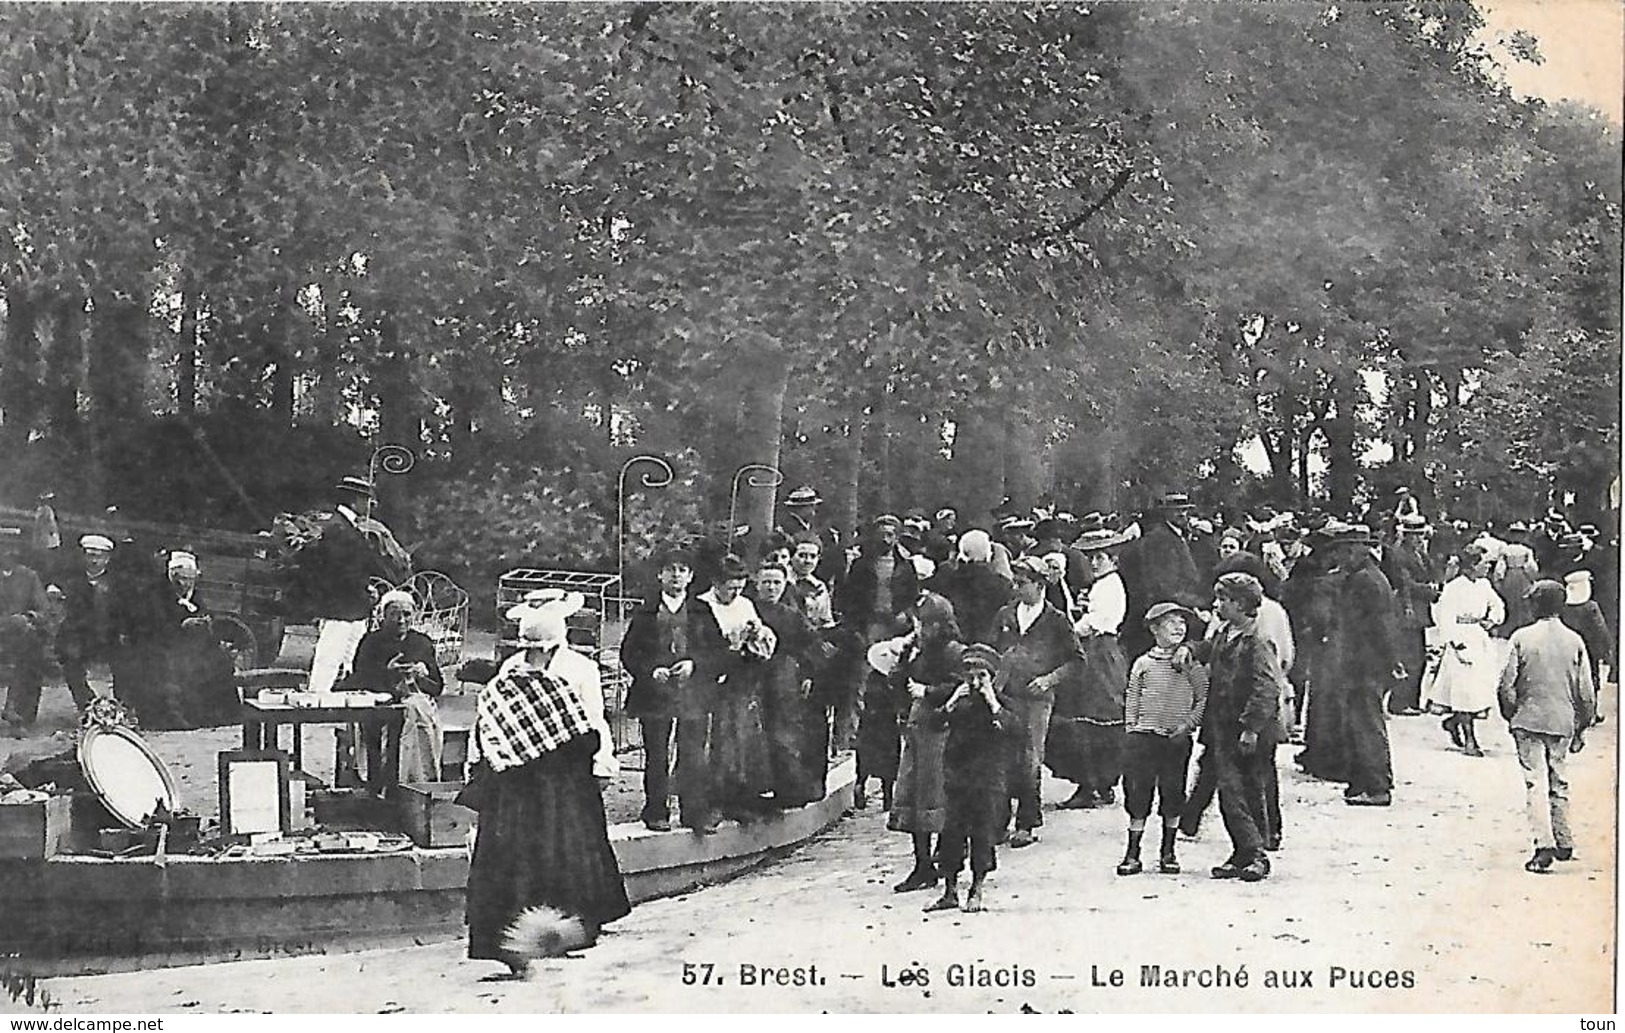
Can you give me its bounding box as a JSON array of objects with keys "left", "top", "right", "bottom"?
[{"left": 466, "top": 736, "right": 632, "bottom": 962}]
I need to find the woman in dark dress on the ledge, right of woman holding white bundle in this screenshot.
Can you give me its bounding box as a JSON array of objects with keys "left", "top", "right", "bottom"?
[{"left": 752, "top": 562, "right": 829, "bottom": 807}]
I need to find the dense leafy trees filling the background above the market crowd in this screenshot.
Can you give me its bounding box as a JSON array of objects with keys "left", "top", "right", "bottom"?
[{"left": 0, "top": 0, "right": 1620, "bottom": 568}]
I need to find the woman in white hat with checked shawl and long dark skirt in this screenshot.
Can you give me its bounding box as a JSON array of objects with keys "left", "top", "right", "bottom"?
[{"left": 468, "top": 606, "right": 632, "bottom": 975}]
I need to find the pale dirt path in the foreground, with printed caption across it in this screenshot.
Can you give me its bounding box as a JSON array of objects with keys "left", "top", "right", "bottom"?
[{"left": 25, "top": 704, "right": 1619, "bottom": 1014}]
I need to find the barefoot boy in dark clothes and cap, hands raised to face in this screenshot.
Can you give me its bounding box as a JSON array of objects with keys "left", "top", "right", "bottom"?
[{"left": 925, "top": 643, "right": 1021, "bottom": 911}]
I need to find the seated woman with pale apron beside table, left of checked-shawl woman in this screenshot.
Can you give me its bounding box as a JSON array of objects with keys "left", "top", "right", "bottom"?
[{"left": 345, "top": 590, "right": 445, "bottom": 781}]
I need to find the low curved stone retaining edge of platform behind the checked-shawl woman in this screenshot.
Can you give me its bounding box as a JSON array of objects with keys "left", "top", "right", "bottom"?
[{"left": 0, "top": 755, "right": 856, "bottom": 976}]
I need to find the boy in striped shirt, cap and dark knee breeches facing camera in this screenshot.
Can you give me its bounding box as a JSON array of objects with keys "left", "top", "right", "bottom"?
[{"left": 1118, "top": 603, "right": 1207, "bottom": 875}]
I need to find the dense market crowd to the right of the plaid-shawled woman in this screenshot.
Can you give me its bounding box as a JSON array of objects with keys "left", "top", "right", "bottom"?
[{"left": 621, "top": 487, "right": 1619, "bottom": 910}]
